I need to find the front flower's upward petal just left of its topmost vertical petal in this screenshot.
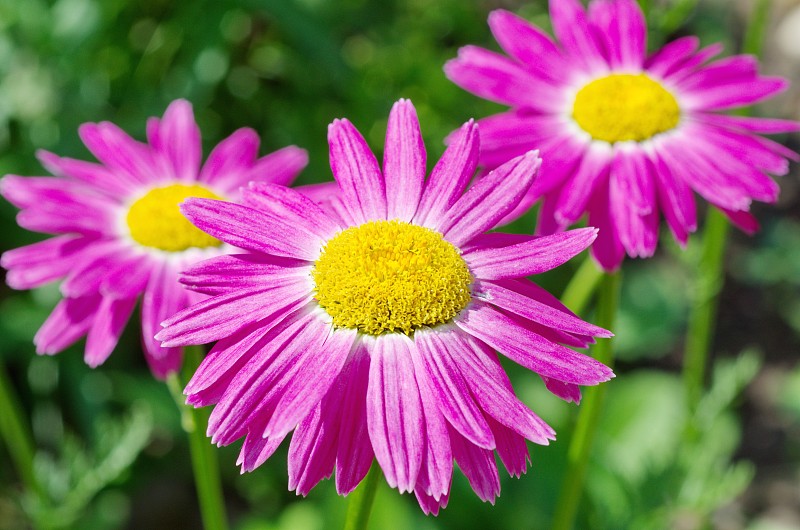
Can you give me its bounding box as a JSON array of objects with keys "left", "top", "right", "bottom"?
[{"left": 328, "top": 119, "right": 386, "bottom": 224}]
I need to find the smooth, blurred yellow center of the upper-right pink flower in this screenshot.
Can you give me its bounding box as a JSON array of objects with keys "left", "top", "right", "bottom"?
[{"left": 572, "top": 74, "right": 681, "bottom": 143}]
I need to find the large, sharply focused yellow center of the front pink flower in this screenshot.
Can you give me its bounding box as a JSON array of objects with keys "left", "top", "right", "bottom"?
[{"left": 311, "top": 221, "right": 472, "bottom": 335}]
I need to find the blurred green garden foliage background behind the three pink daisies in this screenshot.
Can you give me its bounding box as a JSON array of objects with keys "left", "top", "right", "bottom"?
[{"left": 0, "top": 0, "right": 800, "bottom": 530}]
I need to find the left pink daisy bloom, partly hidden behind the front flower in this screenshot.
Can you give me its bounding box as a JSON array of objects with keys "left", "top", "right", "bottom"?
[{"left": 0, "top": 100, "right": 307, "bottom": 377}]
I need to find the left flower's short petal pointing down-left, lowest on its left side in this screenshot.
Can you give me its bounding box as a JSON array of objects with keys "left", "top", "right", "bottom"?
[{"left": 33, "top": 294, "right": 100, "bottom": 355}]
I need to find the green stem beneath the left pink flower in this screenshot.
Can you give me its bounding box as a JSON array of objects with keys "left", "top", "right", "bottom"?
[{"left": 167, "top": 346, "right": 228, "bottom": 530}]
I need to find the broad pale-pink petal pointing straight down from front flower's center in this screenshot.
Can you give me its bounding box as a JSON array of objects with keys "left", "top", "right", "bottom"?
[{"left": 364, "top": 333, "right": 425, "bottom": 493}]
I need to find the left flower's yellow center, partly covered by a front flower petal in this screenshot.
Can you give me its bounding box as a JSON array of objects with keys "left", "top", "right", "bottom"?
[{"left": 125, "top": 184, "right": 222, "bottom": 252}]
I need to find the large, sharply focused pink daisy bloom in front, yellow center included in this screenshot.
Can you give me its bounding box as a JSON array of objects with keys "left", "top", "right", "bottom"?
[{"left": 157, "top": 100, "right": 613, "bottom": 513}]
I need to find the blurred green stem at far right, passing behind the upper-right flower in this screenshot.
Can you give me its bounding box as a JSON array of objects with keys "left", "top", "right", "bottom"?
[{"left": 683, "top": 0, "right": 769, "bottom": 411}]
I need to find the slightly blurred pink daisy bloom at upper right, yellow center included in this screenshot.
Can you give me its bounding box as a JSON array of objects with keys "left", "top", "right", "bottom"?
[{"left": 445, "top": 0, "right": 798, "bottom": 270}]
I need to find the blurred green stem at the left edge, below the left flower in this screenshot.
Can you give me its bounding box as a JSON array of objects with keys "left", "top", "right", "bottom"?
[{"left": 0, "top": 363, "right": 42, "bottom": 495}]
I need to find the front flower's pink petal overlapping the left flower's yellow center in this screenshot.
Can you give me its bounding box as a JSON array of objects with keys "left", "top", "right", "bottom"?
[{"left": 181, "top": 199, "right": 323, "bottom": 261}]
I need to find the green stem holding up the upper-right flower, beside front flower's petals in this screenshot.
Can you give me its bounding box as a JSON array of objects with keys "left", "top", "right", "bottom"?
[{"left": 552, "top": 272, "right": 621, "bottom": 530}]
